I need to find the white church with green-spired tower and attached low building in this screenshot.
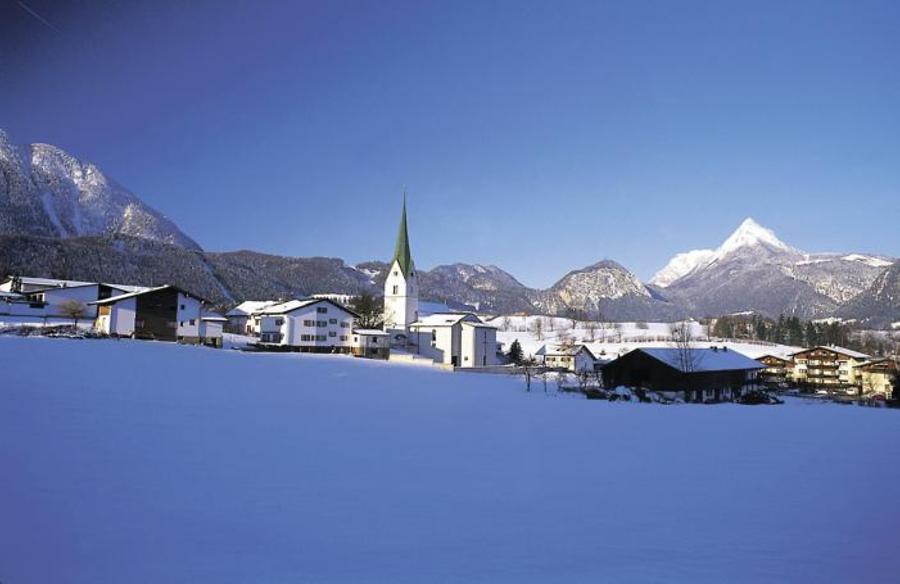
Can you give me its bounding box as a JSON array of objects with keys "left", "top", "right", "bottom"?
[{"left": 384, "top": 195, "right": 498, "bottom": 367}]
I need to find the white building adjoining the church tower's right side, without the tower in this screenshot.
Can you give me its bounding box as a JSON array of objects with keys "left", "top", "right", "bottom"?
[{"left": 409, "top": 312, "right": 497, "bottom": 367}]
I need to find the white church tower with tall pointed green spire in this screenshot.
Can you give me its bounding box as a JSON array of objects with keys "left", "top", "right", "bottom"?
[{"left": 384, "top": 193, "right": 419, "bottom": 333}]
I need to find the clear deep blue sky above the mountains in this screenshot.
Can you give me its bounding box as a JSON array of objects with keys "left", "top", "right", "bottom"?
[{"left": 0, "top": 0, "right": 900, "bottom": 286}]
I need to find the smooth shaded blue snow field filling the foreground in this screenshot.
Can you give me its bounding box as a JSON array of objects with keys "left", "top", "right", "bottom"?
[{"left": 0, "top": 337, "right": 900, "bottom": 584}]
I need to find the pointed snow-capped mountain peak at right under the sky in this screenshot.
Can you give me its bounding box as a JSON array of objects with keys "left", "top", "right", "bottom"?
[{"left": 651, "top": 219, "right": 891, "bottom": 318}]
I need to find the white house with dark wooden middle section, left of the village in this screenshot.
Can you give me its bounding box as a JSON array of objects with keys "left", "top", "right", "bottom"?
[{"left": 91, "top": 285, "right": 221, "bottom": 345}]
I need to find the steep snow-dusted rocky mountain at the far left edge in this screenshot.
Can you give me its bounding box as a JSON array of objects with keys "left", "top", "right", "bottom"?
[{"left": 0, "top": 130, "right": 200, "bottom": 250}]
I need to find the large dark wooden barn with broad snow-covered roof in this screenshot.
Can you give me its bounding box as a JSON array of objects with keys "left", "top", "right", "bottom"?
[{"left": 603, "top": 348, "right": 765, "bottom": 402}]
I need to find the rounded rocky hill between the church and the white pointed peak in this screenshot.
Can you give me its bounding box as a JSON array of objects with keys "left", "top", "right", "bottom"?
[{"left": 532, "top": 260, "right": 684, "bottom": 320}]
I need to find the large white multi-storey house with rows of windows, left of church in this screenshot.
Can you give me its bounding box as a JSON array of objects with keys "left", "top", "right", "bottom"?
[{"left": 254, "top": 298, "right": 359, "bottom": 353}]
